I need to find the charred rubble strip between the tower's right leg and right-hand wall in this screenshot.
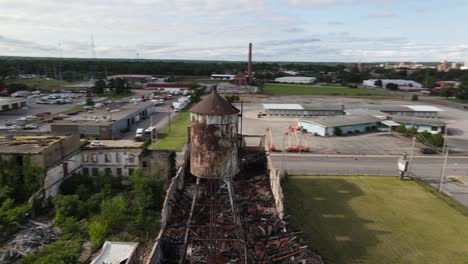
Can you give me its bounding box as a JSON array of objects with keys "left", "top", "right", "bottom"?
[{"left": 237, "top": 175, "right": 322, "bottom": 264}]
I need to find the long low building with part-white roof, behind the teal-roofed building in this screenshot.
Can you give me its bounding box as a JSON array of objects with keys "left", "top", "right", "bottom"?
[{"left": 263, "top": 104, "right": 345, "bottom": 117}]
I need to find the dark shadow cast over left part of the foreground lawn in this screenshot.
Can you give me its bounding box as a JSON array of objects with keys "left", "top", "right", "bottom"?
[{"left": 283, "top": 177, "right": 389, "bottom": 264}]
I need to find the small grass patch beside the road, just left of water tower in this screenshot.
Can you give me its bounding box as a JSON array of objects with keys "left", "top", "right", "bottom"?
[{"left": 148, "top": 112, "right": 190, "bottom": 151}]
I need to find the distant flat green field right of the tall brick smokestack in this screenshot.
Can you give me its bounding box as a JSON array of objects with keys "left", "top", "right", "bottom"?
[{"left": 263, "top": 83, "right": 382, "bottom": 96}]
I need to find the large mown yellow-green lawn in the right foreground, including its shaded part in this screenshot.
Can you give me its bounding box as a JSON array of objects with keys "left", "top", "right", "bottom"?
[{"left": 283, "top": 176, "right": 468, "bottom": 264}]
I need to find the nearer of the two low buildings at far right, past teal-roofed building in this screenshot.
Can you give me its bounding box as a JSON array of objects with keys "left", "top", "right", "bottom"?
[{"left": 391, "top": 116, "right": 446, "bottom": 134}]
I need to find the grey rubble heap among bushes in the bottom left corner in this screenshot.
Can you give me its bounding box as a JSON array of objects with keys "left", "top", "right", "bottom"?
[{"left": 0, "top": 224, "right": 61, "bottom": 264}]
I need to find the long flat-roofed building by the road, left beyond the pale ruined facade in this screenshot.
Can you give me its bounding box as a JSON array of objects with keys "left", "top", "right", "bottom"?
[{"left": 50, "top": 101, "right": 154, "bottom": 139}]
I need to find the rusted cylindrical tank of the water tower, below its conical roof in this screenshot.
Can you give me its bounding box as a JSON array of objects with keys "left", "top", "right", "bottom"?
[{"left": 190, "top": 113, "right": 239, "bottom": 179}]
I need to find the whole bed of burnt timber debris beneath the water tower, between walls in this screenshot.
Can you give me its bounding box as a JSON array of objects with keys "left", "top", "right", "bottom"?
[{"left": 160, "top": 172, "right": 322, "bottom": 263}]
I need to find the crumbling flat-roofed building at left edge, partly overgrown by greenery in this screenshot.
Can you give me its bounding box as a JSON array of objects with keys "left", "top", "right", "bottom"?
[{"left": 0, "top": 135, "right": 81, "bottom": 201}]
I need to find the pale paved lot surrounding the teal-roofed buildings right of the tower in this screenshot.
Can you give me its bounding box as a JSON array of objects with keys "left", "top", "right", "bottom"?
[{"left": 237, "top": 97, "right": 468, "bottom": 155}]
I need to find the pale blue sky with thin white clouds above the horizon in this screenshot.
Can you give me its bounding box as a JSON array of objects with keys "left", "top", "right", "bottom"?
[{"left": 0, "top": 0, "right": 468, "bottom": 63}]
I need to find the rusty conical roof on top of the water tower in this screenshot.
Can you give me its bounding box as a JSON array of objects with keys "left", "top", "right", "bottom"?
[{"left": 190, "top": 89, "right": 239, "bottom": 115}]
